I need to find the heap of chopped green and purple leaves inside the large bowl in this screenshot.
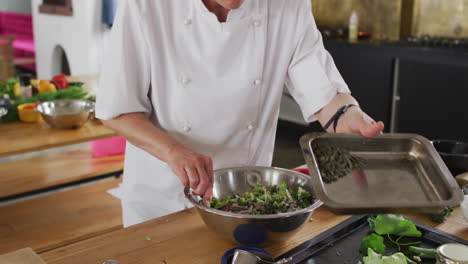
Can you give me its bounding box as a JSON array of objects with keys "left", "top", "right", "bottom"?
[{"left": 208, "top": 182, "right": 315, "bottom": 215}]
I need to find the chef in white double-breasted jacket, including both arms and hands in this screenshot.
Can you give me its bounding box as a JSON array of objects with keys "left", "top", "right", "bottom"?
[{"left": 96, "top": 0, "right": 383, "bottom": 226}]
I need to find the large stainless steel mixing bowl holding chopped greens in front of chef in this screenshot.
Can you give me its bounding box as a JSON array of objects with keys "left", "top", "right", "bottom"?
[{"left": 184, "top": 167, "right": 322, "bottom": 246}]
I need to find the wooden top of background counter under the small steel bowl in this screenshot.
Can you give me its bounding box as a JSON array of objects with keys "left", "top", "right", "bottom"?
[{"left": 0, "top": 120, "right": 116, "bottom": 157}]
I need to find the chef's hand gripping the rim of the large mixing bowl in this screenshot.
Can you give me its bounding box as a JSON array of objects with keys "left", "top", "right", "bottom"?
[{"left": 168, "top": 146, "right": 213, "bottom": 201}]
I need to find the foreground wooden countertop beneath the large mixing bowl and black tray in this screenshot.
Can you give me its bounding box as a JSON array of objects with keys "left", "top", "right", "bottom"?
[{"left": 41, "top": 207, "right": 468, "bottom": 264}]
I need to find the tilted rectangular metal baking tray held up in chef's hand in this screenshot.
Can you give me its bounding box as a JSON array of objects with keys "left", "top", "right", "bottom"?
[{"left": 300, "top": 133, "right": 463, "bottom": 214}]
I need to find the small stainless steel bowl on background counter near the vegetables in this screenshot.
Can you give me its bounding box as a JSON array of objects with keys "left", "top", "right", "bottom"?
[{"left": 36, "top": 100, "right": 94, "bottom": 129}]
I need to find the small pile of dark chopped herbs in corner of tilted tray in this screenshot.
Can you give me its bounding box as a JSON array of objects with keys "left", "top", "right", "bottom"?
[{"left": 314, "top": 145, "right": 366, "bottom": 183}]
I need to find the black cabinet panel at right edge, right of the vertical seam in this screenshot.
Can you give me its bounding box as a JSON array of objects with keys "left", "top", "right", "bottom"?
[{"left": 395, "top": 56, "right": 468, "bottom": 141}]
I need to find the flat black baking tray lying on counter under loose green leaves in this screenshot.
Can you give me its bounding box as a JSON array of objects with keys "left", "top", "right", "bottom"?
[{"left": 276, "top": 215, "right": 468, "bottom": 264}]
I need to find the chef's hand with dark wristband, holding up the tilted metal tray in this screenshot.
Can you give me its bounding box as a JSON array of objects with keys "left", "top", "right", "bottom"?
[{"left": 336, "top": 107, "right": 385, "bottom": 137}]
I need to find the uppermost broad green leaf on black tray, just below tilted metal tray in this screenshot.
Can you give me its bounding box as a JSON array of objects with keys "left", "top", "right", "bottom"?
[{"left": 368, "top": 214, "right": 422, "bottom": 237}]
